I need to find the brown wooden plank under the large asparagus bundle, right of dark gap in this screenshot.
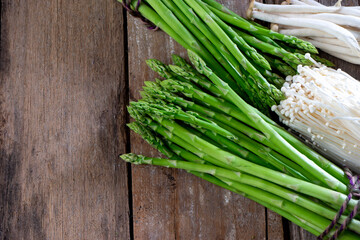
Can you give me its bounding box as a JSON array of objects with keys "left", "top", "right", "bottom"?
[{"left": 128, "top": 1, "right": 266, "bottom": 239}]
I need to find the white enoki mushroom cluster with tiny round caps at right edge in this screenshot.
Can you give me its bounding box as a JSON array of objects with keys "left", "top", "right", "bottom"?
[{"left": 272, "top": 55, "right": 360, "bottom": 170}]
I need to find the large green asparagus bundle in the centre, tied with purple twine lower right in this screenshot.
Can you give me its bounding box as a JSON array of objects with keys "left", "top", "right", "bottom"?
[{"left": 121, "top": 51, "right": 360, "bottom": 240}]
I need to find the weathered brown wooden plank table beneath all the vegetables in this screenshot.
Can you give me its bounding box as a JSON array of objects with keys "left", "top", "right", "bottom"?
[{"left": 0, "top": 0, "right": 360, "bottom": 240}]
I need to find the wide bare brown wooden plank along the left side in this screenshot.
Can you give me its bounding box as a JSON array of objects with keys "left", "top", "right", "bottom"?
[{"left": 0, "top": 0, "right": 129, "bottom": 239}]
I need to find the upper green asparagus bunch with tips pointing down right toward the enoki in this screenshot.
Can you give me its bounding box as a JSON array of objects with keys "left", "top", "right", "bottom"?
[{"left": 119, "top": 0, "right": 332, "bottom": 115}]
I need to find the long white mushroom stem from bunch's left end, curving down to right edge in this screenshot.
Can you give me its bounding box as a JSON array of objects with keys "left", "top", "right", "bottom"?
[{"left": 252, "top": 11, "right": 360, "bottom": 55}]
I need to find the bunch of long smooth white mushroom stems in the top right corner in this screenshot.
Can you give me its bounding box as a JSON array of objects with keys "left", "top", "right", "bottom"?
[{"left": 248, "top": 0, "right": 360, "bottom": 64}]
